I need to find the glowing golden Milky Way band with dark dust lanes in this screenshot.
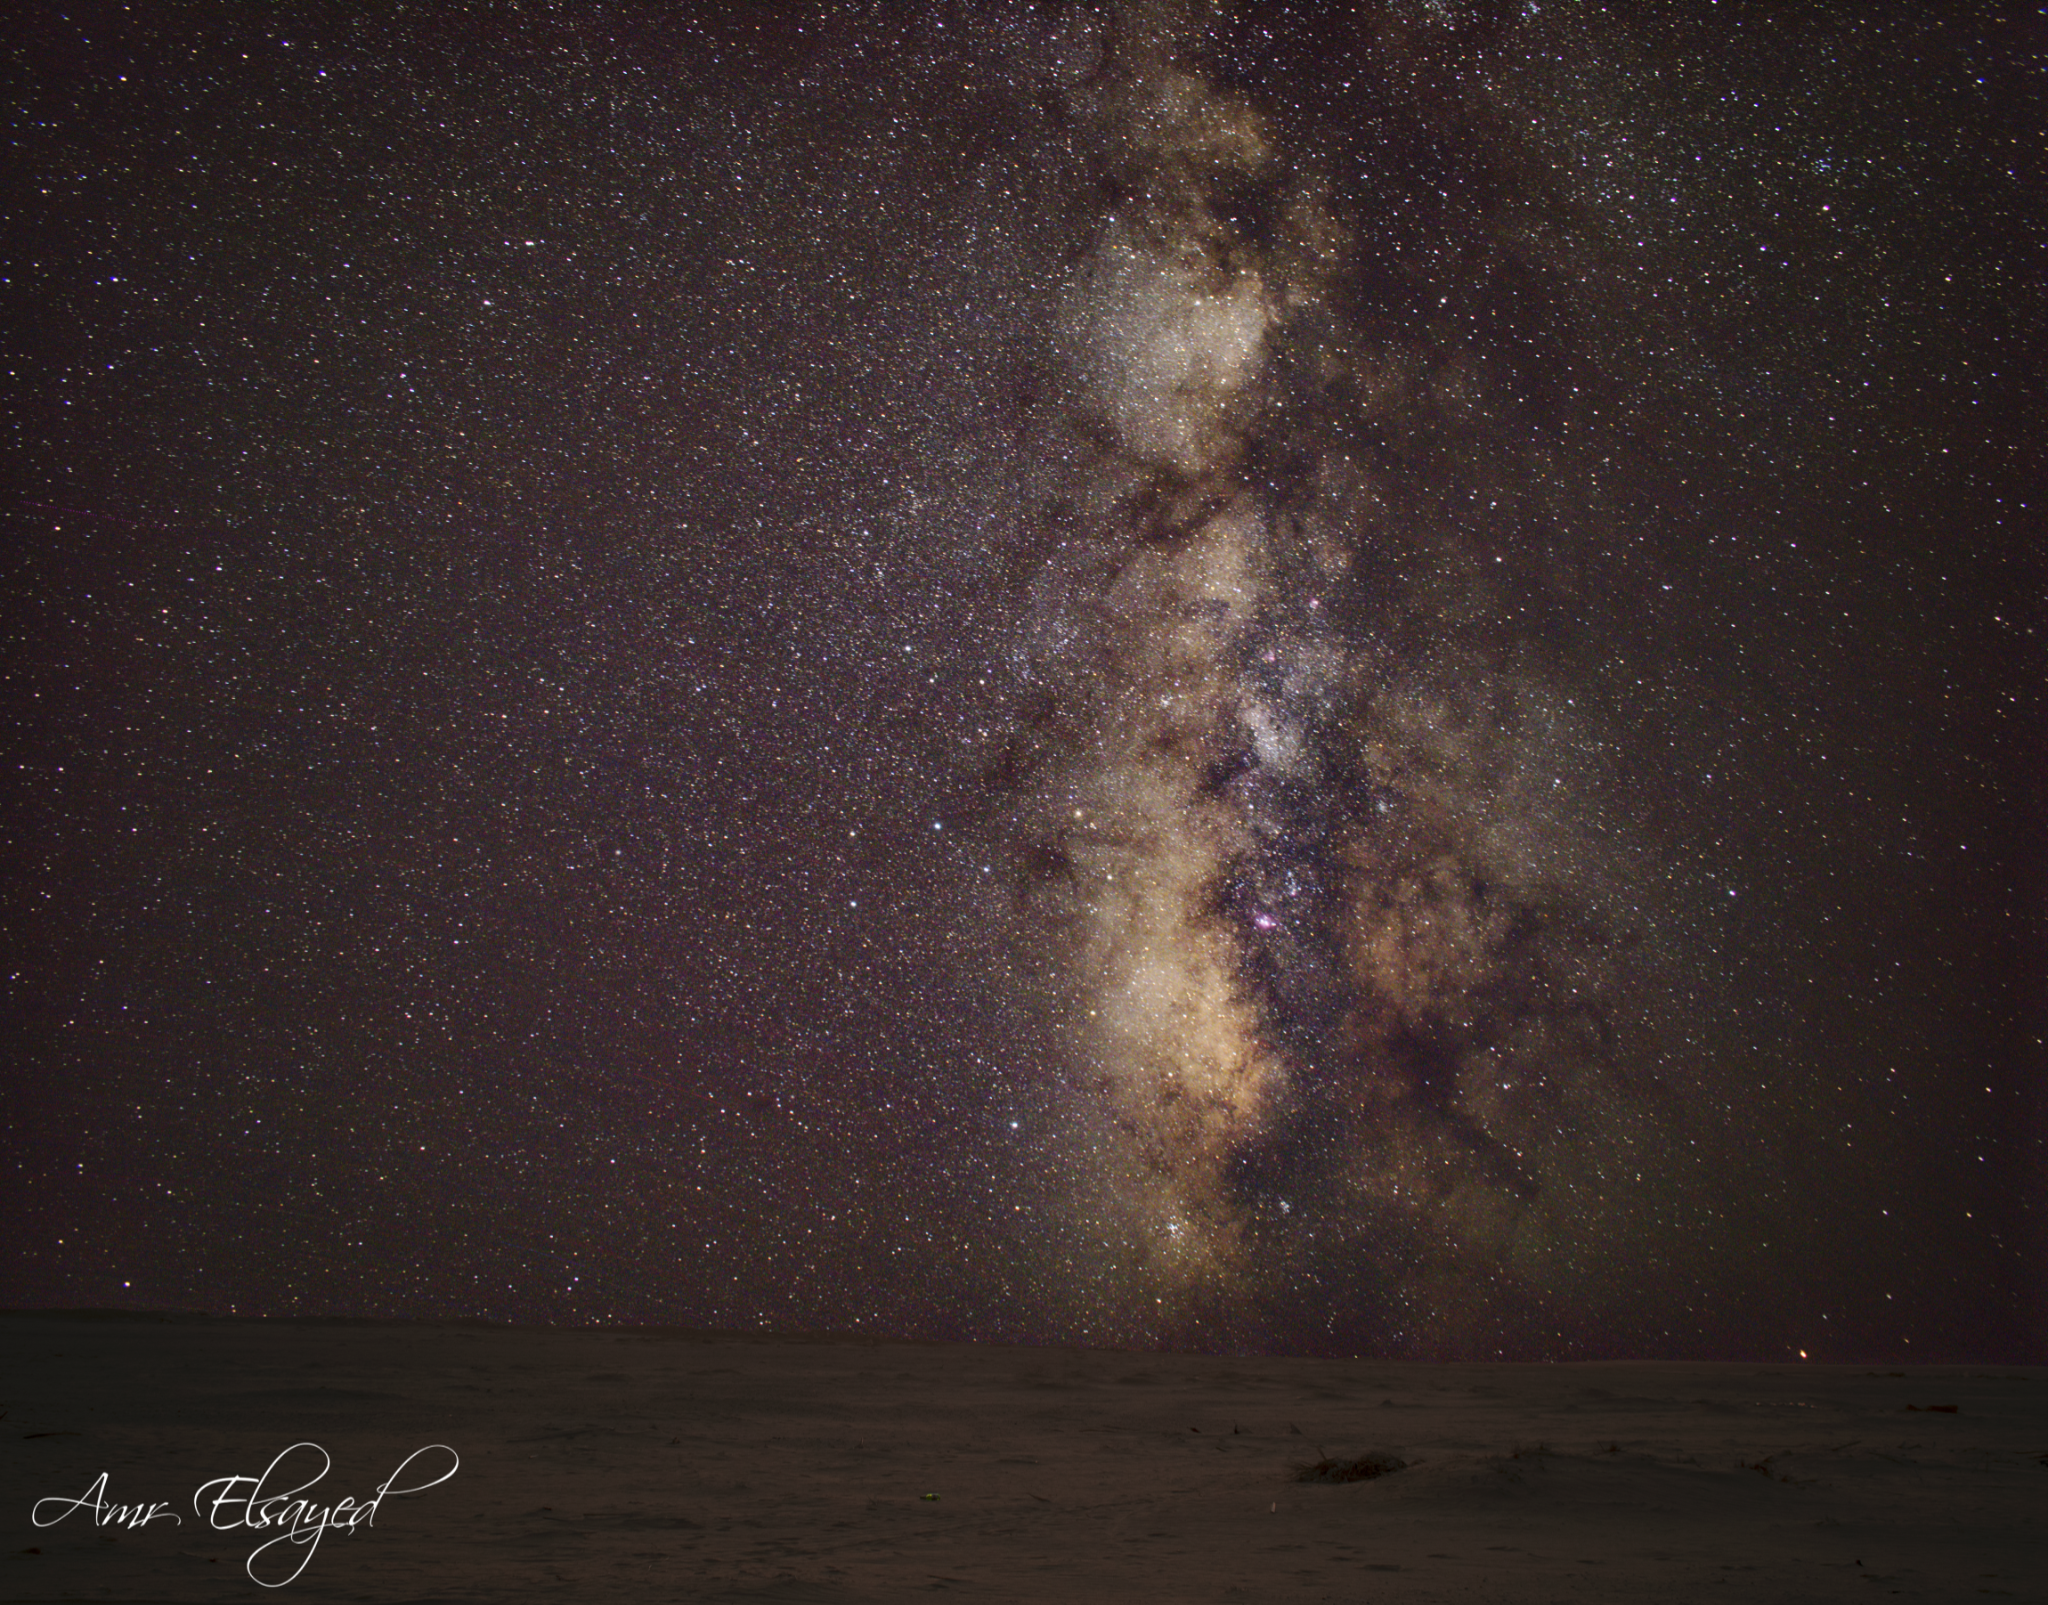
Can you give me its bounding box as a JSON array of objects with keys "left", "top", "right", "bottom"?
[{"left": 970, "top": 8, "right": 1679, "bottom": 1341}]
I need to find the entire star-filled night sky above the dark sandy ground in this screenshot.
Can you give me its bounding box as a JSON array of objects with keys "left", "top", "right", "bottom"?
[{"left": 0, "top": 0, "right": 2048, "bottom": 1361}]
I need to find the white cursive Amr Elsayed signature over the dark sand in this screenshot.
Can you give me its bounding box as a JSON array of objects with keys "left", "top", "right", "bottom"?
[{"left": 29, "top": 1443, "right": 463, "bottom": 1589}]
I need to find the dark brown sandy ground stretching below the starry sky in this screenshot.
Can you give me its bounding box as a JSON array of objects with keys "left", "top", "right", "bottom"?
[{"left": 0, "top": 1314, "right": 2048, "bottom": 1603}]
